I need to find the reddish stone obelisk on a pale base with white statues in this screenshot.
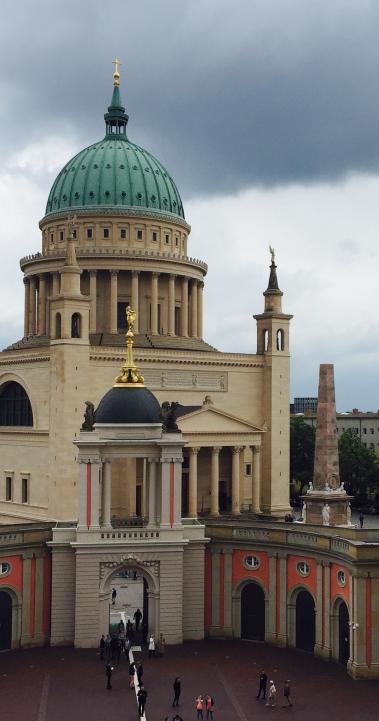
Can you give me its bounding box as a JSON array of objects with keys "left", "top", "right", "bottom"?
[{"left": 303, "top": 363, "right": 351, "bottom": 526}]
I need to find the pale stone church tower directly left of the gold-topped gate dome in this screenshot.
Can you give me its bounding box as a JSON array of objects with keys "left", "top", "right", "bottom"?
[{"left": 49, "top": 219, "right": 91, "bottom": 519}]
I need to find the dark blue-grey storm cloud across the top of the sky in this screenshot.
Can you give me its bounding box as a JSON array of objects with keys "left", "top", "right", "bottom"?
[{"left": 0, "top": 0, "right": 379, "bottom": 196}]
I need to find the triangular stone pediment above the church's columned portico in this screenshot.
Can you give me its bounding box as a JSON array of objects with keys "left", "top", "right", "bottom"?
[{"left": 177, "top": 405, "right": 265, "bottom": 433}]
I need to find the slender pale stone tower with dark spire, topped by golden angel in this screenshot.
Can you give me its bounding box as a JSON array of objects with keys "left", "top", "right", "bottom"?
[{"left": 254, "top": 247, "right": 293, "bottom": 517}]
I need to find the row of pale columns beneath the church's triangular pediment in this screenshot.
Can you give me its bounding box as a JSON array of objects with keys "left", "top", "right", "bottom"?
[{"left": 188, "top": 445, "right": 261, "bottom": 518}]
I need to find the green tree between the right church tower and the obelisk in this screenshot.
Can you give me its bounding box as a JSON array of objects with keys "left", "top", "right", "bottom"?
[{"left": 290, "top": 416, "right": 315, "bottom": 489}]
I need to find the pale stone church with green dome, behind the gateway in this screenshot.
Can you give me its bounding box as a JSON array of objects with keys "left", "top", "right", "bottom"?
[{"left": 0, "top": 73, "right": 291, "bottom": 521}]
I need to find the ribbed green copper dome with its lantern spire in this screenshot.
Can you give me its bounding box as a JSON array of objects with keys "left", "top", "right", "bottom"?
[{"left": 46, "top": 80, "right": 184, "bottom": 218}]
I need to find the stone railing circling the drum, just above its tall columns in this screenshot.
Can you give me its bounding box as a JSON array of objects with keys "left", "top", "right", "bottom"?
[{"left": 20, "top": 246, "right": 208, "bottom": 271}]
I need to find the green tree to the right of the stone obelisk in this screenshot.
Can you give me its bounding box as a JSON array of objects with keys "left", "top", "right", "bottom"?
[{"left": 338, "top": 430, "right": 379, "bottom": 504}]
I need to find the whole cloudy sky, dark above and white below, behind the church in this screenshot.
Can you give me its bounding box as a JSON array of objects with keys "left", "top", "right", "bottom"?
[{"left": 0, "top": 0, "right": 379, "bottom": 410}]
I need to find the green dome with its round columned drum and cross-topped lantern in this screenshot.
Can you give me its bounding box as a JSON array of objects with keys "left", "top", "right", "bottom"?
[{"left": 13, "top": 61, "right": 209, "bottom": 350}]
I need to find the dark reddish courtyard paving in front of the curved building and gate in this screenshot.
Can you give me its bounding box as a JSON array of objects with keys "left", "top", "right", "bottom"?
[{"left": 0, "top": 641, "right": 379, "bottom": 721}]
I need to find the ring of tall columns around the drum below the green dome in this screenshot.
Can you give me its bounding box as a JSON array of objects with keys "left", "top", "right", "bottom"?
[{"left": 24, "top": 269, "right": 204, "bottom": 338}]
